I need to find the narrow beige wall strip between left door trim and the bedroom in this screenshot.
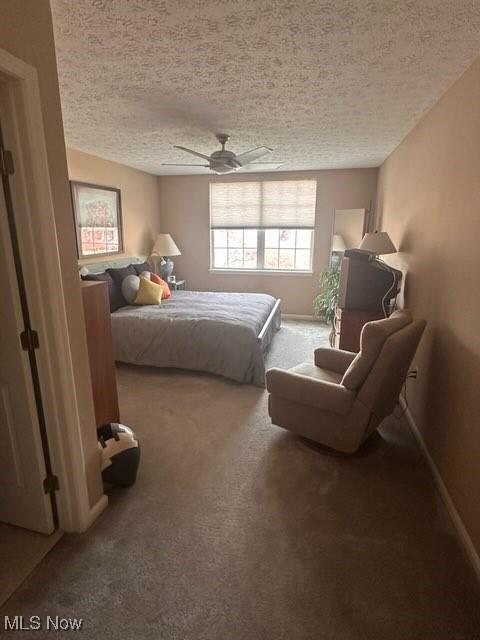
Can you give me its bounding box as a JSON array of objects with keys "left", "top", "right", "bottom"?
[{"left": 0, "top": 0, "right": 103, "bottom": 504}]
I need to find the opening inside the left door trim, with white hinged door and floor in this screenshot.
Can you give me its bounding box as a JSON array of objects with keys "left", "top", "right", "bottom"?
[{"left": 0, "top": 85, "right": 61, "bottom": 603}]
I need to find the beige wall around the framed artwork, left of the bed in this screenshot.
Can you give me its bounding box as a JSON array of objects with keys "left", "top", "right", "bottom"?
[{"left": 67, "top": 149, "right": 160, "bottom": 262}]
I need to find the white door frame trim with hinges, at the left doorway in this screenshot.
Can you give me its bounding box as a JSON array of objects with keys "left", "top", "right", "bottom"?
[{"left": 0, "top": 49, "right": 108, "bottom": 532}]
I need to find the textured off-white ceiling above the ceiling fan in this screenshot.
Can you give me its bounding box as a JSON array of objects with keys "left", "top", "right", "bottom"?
[{"left": 52, "top": 0, "right": 480, "bottom": 174}]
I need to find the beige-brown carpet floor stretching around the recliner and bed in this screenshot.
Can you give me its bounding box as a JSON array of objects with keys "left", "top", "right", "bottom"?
[{"left": 0, "top": 321, "right": 480, "bottom": 640}]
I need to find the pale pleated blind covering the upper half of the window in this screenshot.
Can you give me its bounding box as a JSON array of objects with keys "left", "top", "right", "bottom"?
[{"left": 210, "top": 180, "right": 317, "bottom": 229}]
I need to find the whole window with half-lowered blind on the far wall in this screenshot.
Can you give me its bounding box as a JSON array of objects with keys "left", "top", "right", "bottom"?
[{"left": 210, "top": 180, "right": 317, "bottom": 271}]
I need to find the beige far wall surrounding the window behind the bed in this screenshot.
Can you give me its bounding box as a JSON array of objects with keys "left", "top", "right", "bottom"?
[{"left": 159, "top": 169, "right": 377, "bottom": 315}]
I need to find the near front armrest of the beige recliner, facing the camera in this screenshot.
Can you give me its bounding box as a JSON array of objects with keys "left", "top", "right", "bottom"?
[{"left": 267, "top": 369, "right": 355, "bottom": 415}]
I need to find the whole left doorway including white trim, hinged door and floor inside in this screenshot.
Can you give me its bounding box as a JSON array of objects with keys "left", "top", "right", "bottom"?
[{"left": 0, "top": 49, "right": 108, "bottom": 600}]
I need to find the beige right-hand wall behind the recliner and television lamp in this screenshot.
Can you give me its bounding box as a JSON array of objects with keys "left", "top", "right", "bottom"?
[{"left": 378, "top": 58, "right": 480, "bottom": 552}]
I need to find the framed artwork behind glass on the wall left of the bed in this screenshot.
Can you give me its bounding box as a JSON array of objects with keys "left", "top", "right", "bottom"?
[{"left": 70, "top": 180, "right": 123, "bottom": 258}]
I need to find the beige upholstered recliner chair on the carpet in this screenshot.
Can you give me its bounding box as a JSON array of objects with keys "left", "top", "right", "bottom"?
[{"left": 267, "top": 310, "right": 425, "bottom": 453}]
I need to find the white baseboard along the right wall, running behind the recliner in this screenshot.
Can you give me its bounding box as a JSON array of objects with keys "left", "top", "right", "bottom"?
[{"left": 400, "top": 398, "right": 480, "bottom": 581}]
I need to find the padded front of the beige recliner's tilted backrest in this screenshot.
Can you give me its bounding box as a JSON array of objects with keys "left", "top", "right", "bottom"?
[{"left": 342, "top": 310, "right": 412, "bottom": 389}]
